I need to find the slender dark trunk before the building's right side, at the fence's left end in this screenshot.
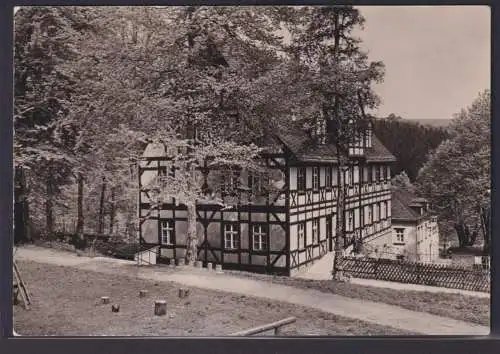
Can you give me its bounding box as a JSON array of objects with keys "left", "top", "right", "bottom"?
[{"left": 332, "top": 155, "right": 346, "bottom": 280}]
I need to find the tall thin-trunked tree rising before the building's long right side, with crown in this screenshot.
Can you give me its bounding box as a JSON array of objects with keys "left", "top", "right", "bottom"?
[{"left": 282, "top": 6, "right": 384, "bottom": 279}]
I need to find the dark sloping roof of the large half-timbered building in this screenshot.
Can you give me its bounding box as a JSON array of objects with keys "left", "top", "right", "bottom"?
[{"left": 276, "top": 123, "right": 396, "bottom": 163}]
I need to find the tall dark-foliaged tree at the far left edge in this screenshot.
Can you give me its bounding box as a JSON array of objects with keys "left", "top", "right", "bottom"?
[{"left": 14, "top": 7, "right": 94, "bottom": 241}]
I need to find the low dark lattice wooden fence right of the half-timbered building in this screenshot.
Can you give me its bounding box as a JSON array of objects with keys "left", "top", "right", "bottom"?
[{"left": 343, "top": 257, "right": 490, "bottom": 292}]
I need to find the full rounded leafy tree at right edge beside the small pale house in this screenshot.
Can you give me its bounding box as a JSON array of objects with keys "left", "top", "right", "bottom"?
[{"left": 417, "top": 91, "right": 491, "bottom": 252}]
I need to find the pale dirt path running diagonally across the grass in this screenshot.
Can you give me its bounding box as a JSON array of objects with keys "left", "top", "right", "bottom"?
[{"left": 16, "top": 247, "right": 489, "bottom": 335}]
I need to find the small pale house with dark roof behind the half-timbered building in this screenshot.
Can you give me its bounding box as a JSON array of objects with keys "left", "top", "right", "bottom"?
[{"left": 388, "top": 188, "right": 439, "bottom": 263}]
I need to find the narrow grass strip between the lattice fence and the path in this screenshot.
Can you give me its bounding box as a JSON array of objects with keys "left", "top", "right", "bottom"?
[{"left": 225, "top": 271, "right": 490, "bottom": 326}]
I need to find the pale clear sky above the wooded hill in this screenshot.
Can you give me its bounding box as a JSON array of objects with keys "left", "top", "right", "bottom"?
[{"left": 358, "top": 6, "right": 491, "bottom": 119}]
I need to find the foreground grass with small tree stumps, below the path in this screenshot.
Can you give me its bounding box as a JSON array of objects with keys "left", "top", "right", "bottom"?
[{"left": 14, "top": 261, "right": 410, "bottom": 336}]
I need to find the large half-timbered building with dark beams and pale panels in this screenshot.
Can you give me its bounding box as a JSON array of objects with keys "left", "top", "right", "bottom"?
[{"left": 139, "top": 120, "right": 395, "bottom": 275}]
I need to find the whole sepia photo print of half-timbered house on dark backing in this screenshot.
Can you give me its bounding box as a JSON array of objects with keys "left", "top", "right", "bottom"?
[{"left": 9, "top": 5, "right": 492, "bottom": 338}]
